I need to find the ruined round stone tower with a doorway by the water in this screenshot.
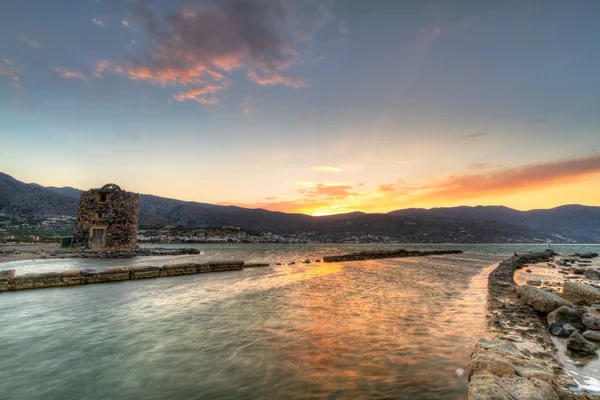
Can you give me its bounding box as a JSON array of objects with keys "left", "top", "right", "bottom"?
[{"left": 73, "top": 183, "right": 140, "bottom": 250}]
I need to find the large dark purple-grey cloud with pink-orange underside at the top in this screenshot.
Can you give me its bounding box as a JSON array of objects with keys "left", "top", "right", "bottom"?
[{"left": 98, "top": 0, "right": 333, "bottom": 104}]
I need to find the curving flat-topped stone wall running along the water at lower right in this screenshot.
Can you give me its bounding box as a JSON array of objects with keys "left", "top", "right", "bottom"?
[{"left": 468, "top": 251, "right": 600, "bottom": 400}]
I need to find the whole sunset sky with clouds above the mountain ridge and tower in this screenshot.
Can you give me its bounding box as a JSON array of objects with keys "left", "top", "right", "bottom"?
[{"left": 0, "top": 0, "right": 600, "bottom": 215}]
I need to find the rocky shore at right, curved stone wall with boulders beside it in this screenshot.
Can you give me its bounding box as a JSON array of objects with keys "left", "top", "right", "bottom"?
[{"left": 469, "top": 251, "right": 600, "bottom": 400}]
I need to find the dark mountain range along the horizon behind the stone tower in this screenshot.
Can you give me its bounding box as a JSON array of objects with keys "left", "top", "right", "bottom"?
[{"left": 0, "top": 173, "right": 600, "bottom": 243}]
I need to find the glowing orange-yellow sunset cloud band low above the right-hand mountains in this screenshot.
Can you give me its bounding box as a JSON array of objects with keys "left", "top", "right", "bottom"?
[{"left": 224, "top": 154, "right": 600, "bottom": 215}]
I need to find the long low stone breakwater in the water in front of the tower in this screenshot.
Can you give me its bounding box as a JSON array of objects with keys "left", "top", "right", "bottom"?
[{"left": 0, "top": 261, "right": 244, "bottom": 292}]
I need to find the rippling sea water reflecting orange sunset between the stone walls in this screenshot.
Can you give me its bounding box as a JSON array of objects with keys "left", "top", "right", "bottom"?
[{"left": 0, "top": 245, "right": 598, "bottom": 400}]
